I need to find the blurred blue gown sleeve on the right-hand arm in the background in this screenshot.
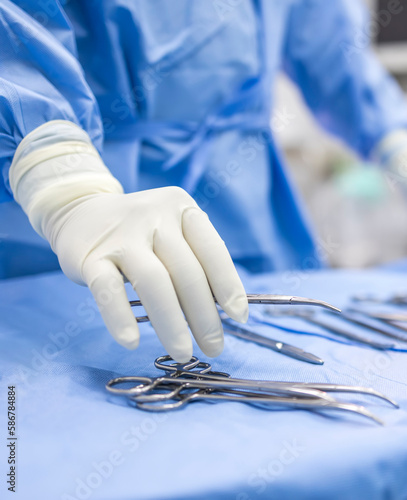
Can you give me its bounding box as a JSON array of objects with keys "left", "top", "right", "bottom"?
[{"left": 283, "top": 0, "right": 407, "bottom": 158}]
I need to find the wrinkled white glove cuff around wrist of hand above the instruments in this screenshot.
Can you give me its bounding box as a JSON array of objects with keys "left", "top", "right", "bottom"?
[{"left": 9, "top": 120, "right": 123, "bottom": 239}]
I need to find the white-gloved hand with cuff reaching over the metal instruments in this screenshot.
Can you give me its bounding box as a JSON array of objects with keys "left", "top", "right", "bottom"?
[{"left": 9, "top": 121, "right": 248, "bottom": 362}]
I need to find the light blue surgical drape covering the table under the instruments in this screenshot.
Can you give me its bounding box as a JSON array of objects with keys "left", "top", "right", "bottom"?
[{"left": 0, "top": 270, "right": 407, "bottom": 500}]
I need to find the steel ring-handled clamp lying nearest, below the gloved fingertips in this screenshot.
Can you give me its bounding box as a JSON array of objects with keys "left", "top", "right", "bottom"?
[{"left": 106, "top": 356, "right": 398, "bottom": 425}]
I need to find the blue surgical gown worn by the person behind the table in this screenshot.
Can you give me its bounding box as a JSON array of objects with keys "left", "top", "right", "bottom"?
[{"left": 0, "top": 0, "right": 407, "bottom": 277}]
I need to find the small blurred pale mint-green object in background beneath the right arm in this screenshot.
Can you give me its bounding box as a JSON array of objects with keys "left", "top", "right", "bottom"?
[{"left": 334, "top": 163, "right": 387, "bottom": 201}]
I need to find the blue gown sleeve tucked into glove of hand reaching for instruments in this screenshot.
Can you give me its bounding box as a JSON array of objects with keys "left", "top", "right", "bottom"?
[{"left": 0, "top": 0, "right": 103, "bottom": 202}]
